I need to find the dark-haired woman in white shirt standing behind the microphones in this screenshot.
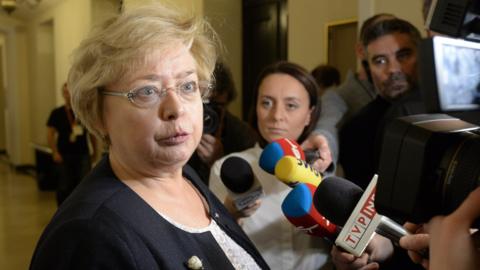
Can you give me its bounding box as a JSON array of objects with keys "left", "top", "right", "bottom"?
[{"left": 209, "top": 62, "right": 331, "bottom": 269}]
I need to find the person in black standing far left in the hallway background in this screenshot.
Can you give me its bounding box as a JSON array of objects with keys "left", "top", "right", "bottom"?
[{"left": 47, "top": 83, "right": 97, "bottom": 205}]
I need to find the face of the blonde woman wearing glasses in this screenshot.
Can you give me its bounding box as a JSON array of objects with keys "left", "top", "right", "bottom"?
[{"left": 103, "top": 45, "right": 203, "bottom": 173}]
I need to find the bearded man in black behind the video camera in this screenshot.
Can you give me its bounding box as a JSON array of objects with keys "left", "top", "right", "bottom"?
[{"left": 339, "top": 19, "right": 424, "bottom": 189}]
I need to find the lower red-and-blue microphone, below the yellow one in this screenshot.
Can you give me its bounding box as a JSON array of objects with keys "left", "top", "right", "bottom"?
[{"left": 282, "top": 183, "right": 340, "bottom": 239}]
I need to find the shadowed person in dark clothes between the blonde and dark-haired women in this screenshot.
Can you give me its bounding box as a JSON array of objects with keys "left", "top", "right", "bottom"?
[{"left": 188, "top": 61, "right": 256, "bottom": 185}]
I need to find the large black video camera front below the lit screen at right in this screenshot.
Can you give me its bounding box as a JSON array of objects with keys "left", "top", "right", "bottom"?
[{"left": 375, "top": 114, "right": 480, "bottom": 227}]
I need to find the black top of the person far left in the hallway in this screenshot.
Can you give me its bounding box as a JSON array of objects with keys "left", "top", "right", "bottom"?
[{"left": 47, "top": 106, "right": 88, "bottom": 155}]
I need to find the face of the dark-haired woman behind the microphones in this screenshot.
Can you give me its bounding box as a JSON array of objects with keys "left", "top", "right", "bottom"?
[{"left": 256, "top": 73, "right": 313, "bottom": 142}]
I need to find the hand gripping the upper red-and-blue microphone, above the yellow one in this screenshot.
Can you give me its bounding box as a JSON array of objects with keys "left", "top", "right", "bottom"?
[{"left": 301, "top": 133, "right": 332, "bottom": 172}]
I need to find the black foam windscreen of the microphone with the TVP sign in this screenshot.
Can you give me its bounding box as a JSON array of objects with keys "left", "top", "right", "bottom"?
[{"left": 313, "top": 176, "right": 363, "bottom": 226}]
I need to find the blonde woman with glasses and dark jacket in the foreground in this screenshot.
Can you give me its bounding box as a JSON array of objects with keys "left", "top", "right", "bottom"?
[{"left": 30, "top": 5, "right": 268, "bottom": 269}]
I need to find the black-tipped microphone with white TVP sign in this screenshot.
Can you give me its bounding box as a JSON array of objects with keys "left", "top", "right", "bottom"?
[{"left": 313, "top": 175, "right": 409, "bottom": 256}]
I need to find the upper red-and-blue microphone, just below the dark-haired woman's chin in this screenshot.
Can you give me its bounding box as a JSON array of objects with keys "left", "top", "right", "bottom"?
[{"left": 258, "top": 138, "right": 305, "bottom": 174}]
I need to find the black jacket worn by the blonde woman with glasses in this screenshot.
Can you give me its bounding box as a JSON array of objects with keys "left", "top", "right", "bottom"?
[{"left": 30, "top": 157, "right": 268, "bottom": 269}]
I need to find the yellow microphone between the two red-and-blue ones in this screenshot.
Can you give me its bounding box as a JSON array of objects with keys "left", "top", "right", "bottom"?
[{"left": 275, "top": 156, "right": 322, "bottom": 187}]
